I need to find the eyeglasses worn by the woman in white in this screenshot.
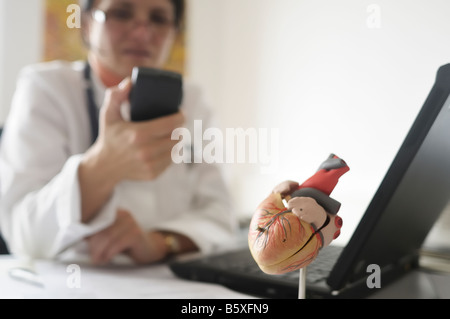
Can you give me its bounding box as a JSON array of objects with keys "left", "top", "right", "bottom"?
[{"left": 92, "top": 8, "right": 175, "bottom": 33}]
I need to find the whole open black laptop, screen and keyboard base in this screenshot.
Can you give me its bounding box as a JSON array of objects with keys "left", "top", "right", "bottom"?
[{"left": 170, "top": 64, "right": 450, "bottom": 298}]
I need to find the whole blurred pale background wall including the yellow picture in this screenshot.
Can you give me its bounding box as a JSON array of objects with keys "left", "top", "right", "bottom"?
[{"left": 0, "top": 0, "right": 450, "bottom": 248}]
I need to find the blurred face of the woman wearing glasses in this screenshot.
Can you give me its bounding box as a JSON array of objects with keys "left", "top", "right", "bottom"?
[{"left": 87, "top": 0, "right": 177, "bottom": 77}]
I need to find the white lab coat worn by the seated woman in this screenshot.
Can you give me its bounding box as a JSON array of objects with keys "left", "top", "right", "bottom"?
[{"left": 0, "top": 61, "right": 235, "bottom": 259}]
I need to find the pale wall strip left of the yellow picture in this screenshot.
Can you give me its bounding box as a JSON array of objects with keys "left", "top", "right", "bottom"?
[{"left": 0, "top": 0, "right": 44, "bottom": 125}]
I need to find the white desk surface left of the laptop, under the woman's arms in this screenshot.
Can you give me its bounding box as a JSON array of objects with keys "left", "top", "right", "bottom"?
[{"left": 0, "top": 256, "right": 252, "bottom": 299}]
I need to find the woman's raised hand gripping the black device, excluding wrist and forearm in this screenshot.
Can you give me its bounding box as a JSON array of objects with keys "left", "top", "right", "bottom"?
[{"left": 95, "top": 78, "right": 184, "bottom": 182}]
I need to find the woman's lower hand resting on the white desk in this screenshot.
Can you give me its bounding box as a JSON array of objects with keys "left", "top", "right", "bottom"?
[{"left": 86, "top": 210, "right": 168, "bottom": 265}]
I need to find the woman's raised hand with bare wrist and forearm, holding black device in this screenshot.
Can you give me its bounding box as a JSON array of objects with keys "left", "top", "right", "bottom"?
[{"left": 78, "top": 78, "right": 184, "bottom": 223}]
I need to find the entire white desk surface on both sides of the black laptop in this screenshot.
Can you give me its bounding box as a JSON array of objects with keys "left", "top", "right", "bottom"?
[{"left": 0, "top": 256, "right": 450, "bottom": 299}]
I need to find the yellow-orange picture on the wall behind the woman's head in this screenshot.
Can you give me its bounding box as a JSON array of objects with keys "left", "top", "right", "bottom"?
[{"left": 44, "top": 0, "right": 186, "bottom": 73}]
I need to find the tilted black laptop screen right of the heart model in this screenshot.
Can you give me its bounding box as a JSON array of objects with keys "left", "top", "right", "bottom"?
[{"left": 327, "top": 64, "right": 450, "bottom": 290}]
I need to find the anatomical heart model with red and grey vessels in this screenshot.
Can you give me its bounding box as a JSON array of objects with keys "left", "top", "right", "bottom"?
[{"left": 248, "top": 154, "right": 350, "bottom": 274}]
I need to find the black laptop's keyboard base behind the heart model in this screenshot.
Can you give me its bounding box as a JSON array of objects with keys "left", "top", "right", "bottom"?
[{"left": 170, "top": 246, "right": 342, "bottom": 298}]
